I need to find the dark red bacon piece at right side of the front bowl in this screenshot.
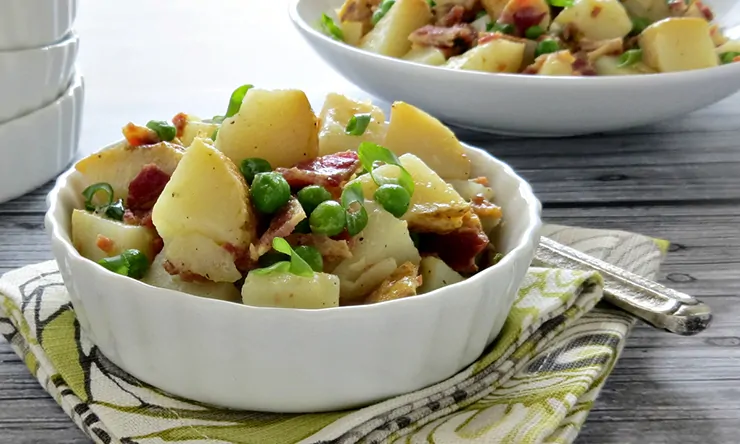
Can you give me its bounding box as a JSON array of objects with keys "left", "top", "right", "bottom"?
[{"left": 420, "top": 212, "right": 489, "bottom": 273}]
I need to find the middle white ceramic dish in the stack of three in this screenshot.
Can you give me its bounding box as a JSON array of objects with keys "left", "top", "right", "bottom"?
[{"left": 0, "top": 32, "right": 79, "bottom": 124}]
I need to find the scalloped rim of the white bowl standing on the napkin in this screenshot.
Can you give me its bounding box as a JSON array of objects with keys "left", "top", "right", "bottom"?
[{"left": 45, "top": 140, "right": 542, "bottom": 316}]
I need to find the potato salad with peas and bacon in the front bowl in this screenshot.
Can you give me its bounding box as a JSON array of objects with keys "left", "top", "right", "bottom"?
[{"left": 71, "top": 85, "right": 502, "bottom": 309}]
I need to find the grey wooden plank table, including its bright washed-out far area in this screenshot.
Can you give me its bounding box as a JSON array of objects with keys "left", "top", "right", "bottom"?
[{"left": 0, "top": 0, "right": 740, "bottom": 444}]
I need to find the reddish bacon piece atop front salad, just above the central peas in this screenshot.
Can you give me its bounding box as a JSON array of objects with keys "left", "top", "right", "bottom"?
[{"left": 275, "top": 151, "right": 360, "bottom": 196}]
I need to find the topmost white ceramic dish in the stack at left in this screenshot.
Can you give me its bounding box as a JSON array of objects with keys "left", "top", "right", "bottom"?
[{"left": 0, "top": 0, "right": 77, "bottom": 51}]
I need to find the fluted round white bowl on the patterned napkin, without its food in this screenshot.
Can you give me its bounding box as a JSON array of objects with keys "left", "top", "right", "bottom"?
[{"left": 46, "top": 140, "right": 540, "bottom": 412}]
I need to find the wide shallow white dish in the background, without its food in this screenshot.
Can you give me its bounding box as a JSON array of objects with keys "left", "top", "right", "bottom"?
[{"left": 289, "top": 0, "right": 740, "bottom": 137}]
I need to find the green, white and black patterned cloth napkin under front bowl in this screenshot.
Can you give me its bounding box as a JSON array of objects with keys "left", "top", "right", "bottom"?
[{"left": 0, "top": 225, "right": 667, "bottom": 444}]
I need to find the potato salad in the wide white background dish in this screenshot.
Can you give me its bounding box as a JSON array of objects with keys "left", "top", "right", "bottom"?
[{"left": 319, "top": 0, "right": 740, "bottom": 76}]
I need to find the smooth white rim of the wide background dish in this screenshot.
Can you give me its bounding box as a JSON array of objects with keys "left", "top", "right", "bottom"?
[{"left": 288, "top": 0, "right": 740, "bottom": 83}]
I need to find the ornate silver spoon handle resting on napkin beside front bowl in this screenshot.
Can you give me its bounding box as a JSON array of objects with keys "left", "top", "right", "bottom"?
[{"left": 534, "top": 237, "right": 712, "bottom": 336}]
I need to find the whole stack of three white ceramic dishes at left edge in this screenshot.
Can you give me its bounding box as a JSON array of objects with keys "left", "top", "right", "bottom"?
[{"left": 0, "top": 0, "right": 84, "bottom": 203}]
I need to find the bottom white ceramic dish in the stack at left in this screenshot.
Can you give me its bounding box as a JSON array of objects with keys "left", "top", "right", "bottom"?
[{"left": 0, "top": 74, "right": 85, "bottom": 203}]
